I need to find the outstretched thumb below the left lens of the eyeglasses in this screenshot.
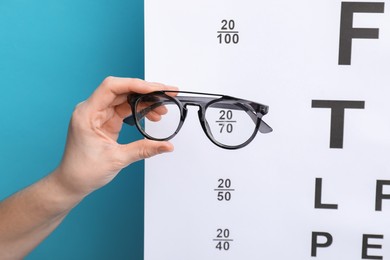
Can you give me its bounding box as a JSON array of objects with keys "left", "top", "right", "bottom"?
[{"left": 121, "top": 139, "right": 173, "bottom": 165}]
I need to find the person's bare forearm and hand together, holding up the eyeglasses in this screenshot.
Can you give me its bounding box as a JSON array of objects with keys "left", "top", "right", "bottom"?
[{"left": 0, "top": 77, "right": 176, "bottom": 260}]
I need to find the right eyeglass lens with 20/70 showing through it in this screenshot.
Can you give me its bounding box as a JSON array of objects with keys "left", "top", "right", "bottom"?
[{"left": 205, "top": 100, "right": 257, "bottom": 147}]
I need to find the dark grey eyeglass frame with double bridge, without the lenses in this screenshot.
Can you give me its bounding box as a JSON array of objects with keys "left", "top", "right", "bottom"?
[{"left": 123, "top": 90, "right": 272, "bottom": 150}]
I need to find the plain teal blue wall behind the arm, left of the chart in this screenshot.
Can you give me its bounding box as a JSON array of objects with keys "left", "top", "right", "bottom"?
[{"left": 0, "top": 0, "right": 144, "bottom": 260}]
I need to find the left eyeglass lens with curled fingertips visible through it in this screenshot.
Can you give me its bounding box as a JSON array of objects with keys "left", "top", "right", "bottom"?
[{"left": 135, "top": 94, "right": 181, "bottom": 140}]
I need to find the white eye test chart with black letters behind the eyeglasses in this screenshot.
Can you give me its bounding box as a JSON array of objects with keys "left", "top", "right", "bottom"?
[{"left": 145, "top": 0, "right": 390, "bottom": 260}]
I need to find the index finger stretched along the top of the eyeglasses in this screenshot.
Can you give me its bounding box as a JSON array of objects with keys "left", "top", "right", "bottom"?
[{"left": 88, "top": 77, "right": 177, "bottom": 110}]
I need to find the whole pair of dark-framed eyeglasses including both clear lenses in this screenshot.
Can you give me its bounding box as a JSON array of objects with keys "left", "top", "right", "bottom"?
[{"left": 123, "top": 91, "right": 272, "bottom": 149}]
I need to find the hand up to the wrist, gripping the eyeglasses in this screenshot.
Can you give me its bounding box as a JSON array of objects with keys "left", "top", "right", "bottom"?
[{"left": 53, "top": 77, "right": 177, "bottom": 196}]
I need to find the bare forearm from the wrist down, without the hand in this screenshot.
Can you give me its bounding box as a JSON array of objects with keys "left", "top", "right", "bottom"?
[{"left": 0, "top": 173, "right": 83, "bottom": 259}]
